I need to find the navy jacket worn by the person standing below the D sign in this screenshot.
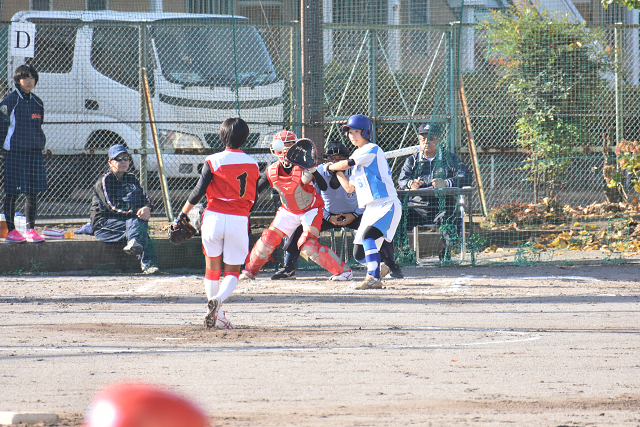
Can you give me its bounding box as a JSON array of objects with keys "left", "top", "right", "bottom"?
[{"left": 0, "top": 89, "right": 47, "bottom": 151}]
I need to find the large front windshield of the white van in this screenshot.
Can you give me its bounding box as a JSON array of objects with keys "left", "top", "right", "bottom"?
[{"left": 152, "top": 25, "right": 277, "bottom": 87}]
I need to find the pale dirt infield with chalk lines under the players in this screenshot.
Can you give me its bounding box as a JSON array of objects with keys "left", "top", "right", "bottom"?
[{"left": 0, "top": 265, "right": 640, "bottom": 426}]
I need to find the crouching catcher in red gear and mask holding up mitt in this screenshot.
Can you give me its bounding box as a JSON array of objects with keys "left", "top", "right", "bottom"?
[{"left": 240, "top": 130, "right": 353, "bottom": 280}]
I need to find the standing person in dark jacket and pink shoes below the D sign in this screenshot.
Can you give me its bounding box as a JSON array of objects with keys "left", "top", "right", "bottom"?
[{"left": 0, "top": 65, "right": 48, "bottom": 243}]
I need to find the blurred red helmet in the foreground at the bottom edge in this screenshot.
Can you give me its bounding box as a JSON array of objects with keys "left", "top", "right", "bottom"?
[{"left": 84, "top": 384, "right": 209, "bottom": 427}]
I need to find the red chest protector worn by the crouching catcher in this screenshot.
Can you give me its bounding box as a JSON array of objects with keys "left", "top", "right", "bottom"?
[{"left": 267, "top": 162, "right": 324, "bottom": 214}]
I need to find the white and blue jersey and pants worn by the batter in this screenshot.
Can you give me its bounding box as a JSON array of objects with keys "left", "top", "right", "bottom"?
[{"left": 349, "top": 142, "right": 402, "bottom": 249}]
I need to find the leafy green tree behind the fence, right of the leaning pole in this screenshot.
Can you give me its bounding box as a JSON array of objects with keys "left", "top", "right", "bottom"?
[{"left": 484, "top": 1, "right": 610, "bottom": 199}]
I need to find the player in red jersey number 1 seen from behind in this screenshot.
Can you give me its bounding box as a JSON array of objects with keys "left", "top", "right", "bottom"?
[{"left": 172, "top": 118, "right": 260, "bottom": 329}]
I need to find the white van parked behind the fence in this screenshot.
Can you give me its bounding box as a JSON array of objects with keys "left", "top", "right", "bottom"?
[{"left": 8, "top": 11, "right": 284, "bottom": 186}]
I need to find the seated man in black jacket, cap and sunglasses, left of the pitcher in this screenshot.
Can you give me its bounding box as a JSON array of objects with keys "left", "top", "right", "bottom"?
[{"left": 91, "top": 144, "right": 159, "bottom": 274}]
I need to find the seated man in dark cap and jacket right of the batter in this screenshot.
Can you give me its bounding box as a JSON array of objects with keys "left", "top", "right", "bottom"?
[{"left": 398, "top": 123, "right": 472, "bottom": 260}]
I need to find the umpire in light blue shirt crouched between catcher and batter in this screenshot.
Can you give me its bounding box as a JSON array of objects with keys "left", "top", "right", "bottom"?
[{"left": 271, "top": 141, "right": 404, "bottom": 280}]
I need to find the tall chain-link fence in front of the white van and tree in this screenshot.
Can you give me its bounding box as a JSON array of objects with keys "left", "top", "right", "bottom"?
[{"left": 0, "top": 0, "right": 640, "bottom": 268}]
